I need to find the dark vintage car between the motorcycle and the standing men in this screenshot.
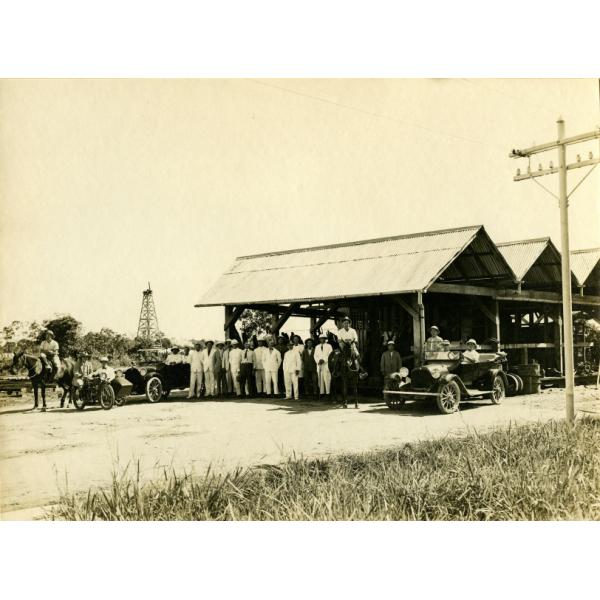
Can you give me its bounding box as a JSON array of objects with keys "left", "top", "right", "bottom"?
[{"left": 123, "top": 349, "right": 190, "bottom": 402}]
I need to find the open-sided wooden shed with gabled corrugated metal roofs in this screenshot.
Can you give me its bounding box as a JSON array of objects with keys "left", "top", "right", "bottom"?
[{"left": 196, "top": 225, "right": 600, "bottom": 384}]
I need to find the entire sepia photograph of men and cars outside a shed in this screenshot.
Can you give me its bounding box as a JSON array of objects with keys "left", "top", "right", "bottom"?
[{"left": 0, "top": 78, "right": 600, "bottom": 521}]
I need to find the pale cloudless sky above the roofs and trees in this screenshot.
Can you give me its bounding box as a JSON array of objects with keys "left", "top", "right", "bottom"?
[{"left": 0, "top": 79, "right": 600, "bottom": 338}]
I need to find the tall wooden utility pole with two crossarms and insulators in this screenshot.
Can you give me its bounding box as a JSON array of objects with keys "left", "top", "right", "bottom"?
[{"left": 509, "top": 117, "right": 600, "bottom": 424}]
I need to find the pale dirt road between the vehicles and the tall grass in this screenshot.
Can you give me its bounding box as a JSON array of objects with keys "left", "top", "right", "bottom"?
[{"left": 0, "top": 387, "right": 600, "bottom": 519}]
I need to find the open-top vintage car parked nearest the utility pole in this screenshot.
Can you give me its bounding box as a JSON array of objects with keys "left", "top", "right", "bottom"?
[{"left": 384, "top": 349, "right": 507, "bottom": 415}]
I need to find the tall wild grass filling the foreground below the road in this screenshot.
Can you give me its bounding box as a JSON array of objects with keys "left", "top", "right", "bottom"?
[{"left": 48, "top": 419, "right": 600, "bottom": 520}]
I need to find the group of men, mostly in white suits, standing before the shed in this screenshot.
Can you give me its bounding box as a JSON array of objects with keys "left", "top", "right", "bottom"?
[{"left": 171, "top": 317, "right": 359, "bottom": 400}]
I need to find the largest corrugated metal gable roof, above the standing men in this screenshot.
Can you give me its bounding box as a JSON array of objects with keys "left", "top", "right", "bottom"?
[{"left": 196, "top": 225, "right": 514, "bottom": 306}]
